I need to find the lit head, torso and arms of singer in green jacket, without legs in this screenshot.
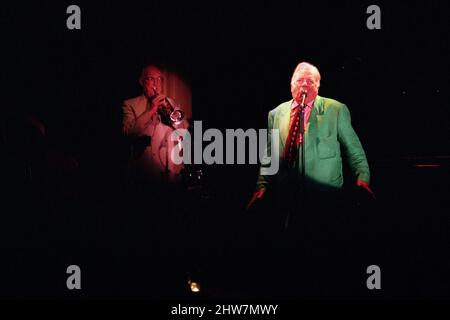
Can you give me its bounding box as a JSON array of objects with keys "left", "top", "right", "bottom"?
[{"left": 247, "top": 62, "right": 374, "bottom": 207}]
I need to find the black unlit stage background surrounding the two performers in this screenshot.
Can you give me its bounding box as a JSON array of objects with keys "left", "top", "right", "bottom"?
[{"left": 0, "top": 1, "right": 450, "bottom": 298}]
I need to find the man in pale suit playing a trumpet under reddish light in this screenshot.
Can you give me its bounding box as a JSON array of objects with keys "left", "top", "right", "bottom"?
[{"left": 122, "top": 65, "right": 188, "bottom": 186}]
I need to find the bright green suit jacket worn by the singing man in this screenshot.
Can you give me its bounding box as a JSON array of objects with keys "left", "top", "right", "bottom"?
[{"left": 257, "top": 96, "right": 370, "bottom": 191}]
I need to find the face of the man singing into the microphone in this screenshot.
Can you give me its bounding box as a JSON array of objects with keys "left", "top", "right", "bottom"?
[{"left": 291, "top": 68, "right": 320, "bottom": 104}]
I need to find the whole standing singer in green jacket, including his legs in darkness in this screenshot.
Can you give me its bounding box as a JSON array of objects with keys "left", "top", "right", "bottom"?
[{"left": 247, "top": 62, "right": 374, "bottom": 297}]
